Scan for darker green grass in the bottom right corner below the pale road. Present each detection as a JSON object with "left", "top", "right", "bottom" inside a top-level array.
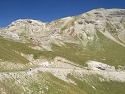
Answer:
[{"left": 67, "top": 74, "right": 125, "bottom": 94}]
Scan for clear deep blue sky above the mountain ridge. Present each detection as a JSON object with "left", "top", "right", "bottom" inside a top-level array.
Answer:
[{"left": 0, "top": 0, "right": 125, "bottom": 27}]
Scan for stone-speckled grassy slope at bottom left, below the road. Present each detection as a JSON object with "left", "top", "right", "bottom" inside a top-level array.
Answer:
[{"left": 0, "top": 72, "right": 88, "bottom": 94}]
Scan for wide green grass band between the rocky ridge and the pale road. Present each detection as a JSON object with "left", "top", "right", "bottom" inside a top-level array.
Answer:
[{"left": 0, "top": 27, "right": 125, "bottom": 66}]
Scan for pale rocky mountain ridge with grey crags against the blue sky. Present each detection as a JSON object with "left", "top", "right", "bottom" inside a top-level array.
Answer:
[{"left": 0, "top": 8, "right": 125, "bottom": 46}]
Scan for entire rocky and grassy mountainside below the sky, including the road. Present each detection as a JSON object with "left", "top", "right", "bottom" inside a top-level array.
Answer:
[{"left": 0, "top": 8, "right": 125, "bottom": 94}]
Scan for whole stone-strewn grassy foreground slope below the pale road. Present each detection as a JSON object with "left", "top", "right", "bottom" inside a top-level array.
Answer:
[{"left": 0, "top": 71, "right": 125, "bottom": 94}]
